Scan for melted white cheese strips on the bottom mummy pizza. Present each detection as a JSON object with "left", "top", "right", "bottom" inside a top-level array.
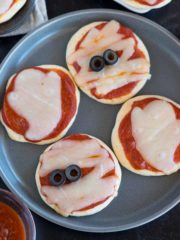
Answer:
[{"left": 39, "top": 139, "right": 117, "bottom": 215}]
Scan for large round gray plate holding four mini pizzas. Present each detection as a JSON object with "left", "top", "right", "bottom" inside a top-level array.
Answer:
[{"left": 0, "top": 9, "right": 180, "bottom": 232}]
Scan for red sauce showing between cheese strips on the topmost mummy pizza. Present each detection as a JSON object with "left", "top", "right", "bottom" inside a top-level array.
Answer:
[{"left": 72, "top": 22, "right": 145, "bottom": 99}]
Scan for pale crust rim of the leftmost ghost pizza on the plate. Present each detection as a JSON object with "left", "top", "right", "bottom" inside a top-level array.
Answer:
[{"left": 0, "top": 65, "right": 80, "bottom": 145}]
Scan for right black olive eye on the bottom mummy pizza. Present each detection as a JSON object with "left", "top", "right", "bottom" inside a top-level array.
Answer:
[{"left": 65, "top": 165, "right": 82, "bottom": 182}]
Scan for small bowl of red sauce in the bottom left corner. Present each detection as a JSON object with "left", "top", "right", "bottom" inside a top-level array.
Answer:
[{"left": 0, "top": 189, "right": 36, "bottom": 240}]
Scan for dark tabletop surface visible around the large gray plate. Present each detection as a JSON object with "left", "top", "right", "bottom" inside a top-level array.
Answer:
[{"left": 0, "top": 0, "right": 180, "bottom": 240}]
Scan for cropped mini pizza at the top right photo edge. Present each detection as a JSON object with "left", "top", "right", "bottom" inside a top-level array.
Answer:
[{"left": 115, "top": 0, "right": 172, "bottom": 13}]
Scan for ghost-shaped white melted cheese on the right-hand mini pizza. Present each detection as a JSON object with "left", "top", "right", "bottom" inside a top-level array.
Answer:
[{"left": 131, "top": 100, "right": 180, "bottom": 172}]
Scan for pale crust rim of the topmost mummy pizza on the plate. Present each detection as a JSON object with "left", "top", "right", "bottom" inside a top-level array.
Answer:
[{"left": 66, "top": 21, "right": 150, "bottom": 104}]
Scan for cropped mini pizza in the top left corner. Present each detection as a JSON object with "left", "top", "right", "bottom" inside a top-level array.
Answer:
[{"left": 0, "top": 0, "right": 27, "bottom": 24}]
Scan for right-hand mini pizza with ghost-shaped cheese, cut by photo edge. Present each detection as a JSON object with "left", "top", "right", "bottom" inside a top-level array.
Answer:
[{"left": 112, "top": 95, "right": 180, "bottom": 176}]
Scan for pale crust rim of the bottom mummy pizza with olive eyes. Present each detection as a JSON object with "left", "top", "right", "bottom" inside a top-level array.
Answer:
[{"left": 35, "top": 134, "right": 121, "bottom": 217}]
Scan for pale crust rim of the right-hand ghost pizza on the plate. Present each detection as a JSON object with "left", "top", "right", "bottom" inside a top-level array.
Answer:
[{"left": 111, "top": 95, "right": 180, "bottom": 176}]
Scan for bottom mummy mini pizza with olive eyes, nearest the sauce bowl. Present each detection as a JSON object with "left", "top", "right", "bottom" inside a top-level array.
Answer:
[{"left": 36, "top": 134, "right": 121, "bottom": 217}]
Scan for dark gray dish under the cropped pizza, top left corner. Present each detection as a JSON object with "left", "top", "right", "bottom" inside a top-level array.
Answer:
[{"left": 0, "top": 0, "right": 36, "bottom": 35}]
